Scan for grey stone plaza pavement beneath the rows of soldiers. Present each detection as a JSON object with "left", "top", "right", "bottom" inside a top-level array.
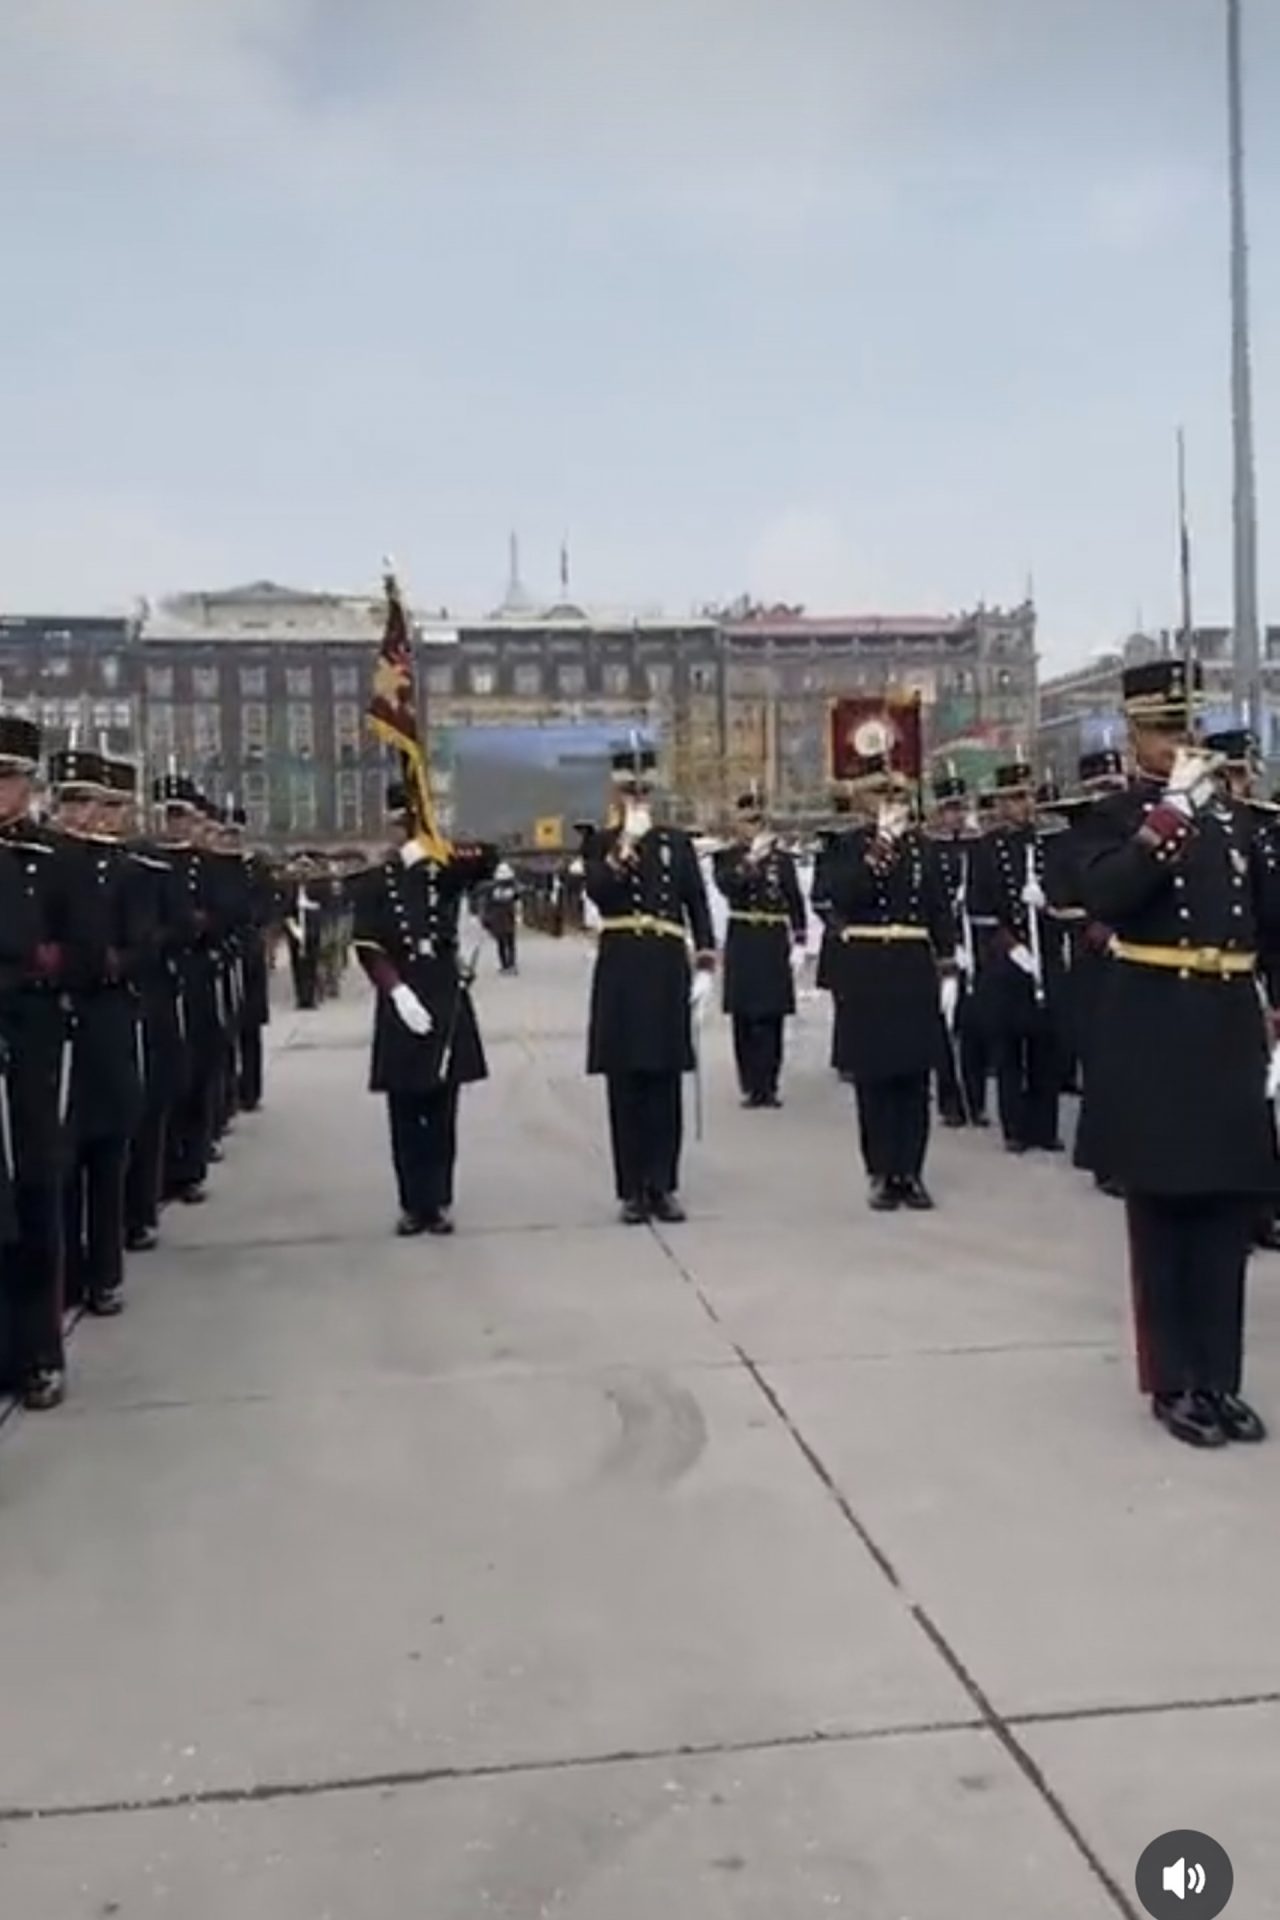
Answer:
[{"left": 0, "top": 939, "right": 1280, "bottom": 1920}]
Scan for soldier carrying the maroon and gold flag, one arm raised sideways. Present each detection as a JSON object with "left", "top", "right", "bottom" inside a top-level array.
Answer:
[{"left": 351, "top": 787, "right": 497, "bottom": 1236}]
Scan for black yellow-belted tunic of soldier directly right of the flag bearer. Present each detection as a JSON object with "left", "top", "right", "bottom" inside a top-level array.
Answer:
[{"left": 585, "top": 826, "right": 716, "bottom": 1073}]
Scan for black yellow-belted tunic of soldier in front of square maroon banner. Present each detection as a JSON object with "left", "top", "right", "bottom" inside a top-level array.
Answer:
[{"left": 825, "top": 826, "right": 956, "bottom": 1083}]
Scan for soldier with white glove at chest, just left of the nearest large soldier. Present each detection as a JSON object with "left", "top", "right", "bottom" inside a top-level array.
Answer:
[{"left": 971, "top": 760, "right": 1065, "bottom": 1154}]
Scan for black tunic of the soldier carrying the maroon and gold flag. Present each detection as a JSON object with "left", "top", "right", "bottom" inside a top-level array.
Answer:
[{"left": 351, "top": 845, "right": 497, "bottom": 1094}]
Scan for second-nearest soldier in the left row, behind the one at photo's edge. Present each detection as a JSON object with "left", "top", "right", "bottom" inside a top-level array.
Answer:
[{"left": 48, "top": 747, "right": 152, "bottom": 1317}]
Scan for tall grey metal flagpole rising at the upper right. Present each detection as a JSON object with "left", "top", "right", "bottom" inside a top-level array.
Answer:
[{"left": 1226, "top": 0, "right": 1268, "bottom": 753}]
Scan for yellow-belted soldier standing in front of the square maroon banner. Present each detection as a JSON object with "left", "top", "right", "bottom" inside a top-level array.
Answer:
[{"left": 827, "top": 756, "right": 956, "bottom": 1213}]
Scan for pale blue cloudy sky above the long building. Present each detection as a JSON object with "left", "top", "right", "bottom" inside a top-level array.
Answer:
[{"left": 0, "top": 0, "right": 1280, "bottom": 668}]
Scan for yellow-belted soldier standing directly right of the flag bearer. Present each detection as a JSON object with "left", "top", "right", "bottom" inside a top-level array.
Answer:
[{"left": 585, "top": 743, "right": 716, "bottom": 1225}]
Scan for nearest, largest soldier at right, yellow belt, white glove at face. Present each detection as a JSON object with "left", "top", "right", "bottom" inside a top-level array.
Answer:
[{"left": 1082, "top": 660, "right": 1280, "bottom": 1446}]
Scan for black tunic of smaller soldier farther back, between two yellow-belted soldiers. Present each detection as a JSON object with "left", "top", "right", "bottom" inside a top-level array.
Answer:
[{"left": 714, "top": 845, "right": 808, "bottom": 1020}]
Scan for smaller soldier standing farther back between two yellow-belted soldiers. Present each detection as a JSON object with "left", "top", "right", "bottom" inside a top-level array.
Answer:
[{"left": 712, "top": 787, "right": 808, "bottom": 1106}]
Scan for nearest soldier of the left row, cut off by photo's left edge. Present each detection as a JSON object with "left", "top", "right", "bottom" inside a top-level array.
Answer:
[{"left": 0, "top": 714, "right": 79, "bottom": 1409}]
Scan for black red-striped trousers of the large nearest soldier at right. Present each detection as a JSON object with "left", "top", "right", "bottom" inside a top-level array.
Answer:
[{"left": 1125, "top": 1194, "right": 1257, "bottom": 1394}]
